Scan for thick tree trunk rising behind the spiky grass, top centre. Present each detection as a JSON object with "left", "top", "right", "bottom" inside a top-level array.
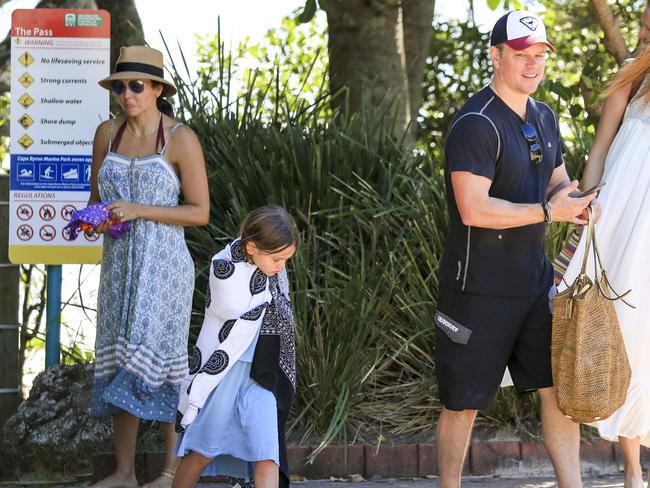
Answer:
[{"left": 327, "top": 0, "right": 434, "bottom": 142}]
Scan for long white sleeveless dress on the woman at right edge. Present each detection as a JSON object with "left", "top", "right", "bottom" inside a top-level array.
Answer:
[{"left": 559, "top": 74, "right": 650, "bottom": 447}]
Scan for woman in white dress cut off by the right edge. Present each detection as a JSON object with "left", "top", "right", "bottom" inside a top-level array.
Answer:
[{"left": 562, "top": 4, "right": 650, "bottom": 488}]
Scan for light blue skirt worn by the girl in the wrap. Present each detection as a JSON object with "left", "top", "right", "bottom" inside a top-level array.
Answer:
[{"left": 176, "top": 360, "right": 280, "bottom": 480}]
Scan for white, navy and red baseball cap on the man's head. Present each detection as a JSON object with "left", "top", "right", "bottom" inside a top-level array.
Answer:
[{"left": 490, "top": 10, "right": 555, "bottom": 52}]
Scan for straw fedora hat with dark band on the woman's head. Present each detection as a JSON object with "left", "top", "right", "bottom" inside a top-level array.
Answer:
[{"left": 99, "top": 46, "right": 176, "bottom": 97}]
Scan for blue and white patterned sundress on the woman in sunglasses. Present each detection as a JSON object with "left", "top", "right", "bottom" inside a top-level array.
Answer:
[{"left": 91, "top": 122, "right": 194, "bottom": 422}]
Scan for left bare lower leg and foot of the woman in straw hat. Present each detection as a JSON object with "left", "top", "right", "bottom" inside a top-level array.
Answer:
[{"left": 89, "top": 412, "right": 140, "bottom": 488}]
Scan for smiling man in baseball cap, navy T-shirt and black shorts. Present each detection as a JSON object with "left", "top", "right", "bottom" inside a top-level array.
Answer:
[{"left": 434, "top": 10, "right": 593, "bottom": 488}]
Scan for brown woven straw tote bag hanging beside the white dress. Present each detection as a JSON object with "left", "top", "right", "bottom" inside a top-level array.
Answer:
[{"left": 551, "top": 207, "right": 632, "bottom": 423}]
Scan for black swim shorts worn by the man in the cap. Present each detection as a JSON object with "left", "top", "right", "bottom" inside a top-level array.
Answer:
[{"left": 434, "top": 287, "right": 553, "bottom": 410}]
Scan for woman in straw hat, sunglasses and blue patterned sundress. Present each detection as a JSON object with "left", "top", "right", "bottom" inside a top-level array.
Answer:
[{"left": 89, "top": 46, "right": 210, "bottom": 488}]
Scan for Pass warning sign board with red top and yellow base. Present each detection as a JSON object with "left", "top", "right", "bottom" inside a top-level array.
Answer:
[{"left": 9, "top": 8, "right": 111, "bottom": 264}]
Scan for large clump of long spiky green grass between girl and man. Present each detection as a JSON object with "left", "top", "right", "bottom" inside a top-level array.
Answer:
[{"left": 165, "top": 33, "right": 446, "bottom": 442}]
